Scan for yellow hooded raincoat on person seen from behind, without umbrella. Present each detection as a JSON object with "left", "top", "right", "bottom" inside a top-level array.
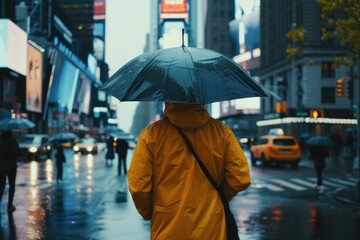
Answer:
[{"left": 128, "top": 103, "right": 250, "bottom": 240}]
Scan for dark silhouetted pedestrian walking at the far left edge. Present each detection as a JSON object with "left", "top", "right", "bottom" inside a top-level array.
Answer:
[{"left": 0, "top": 131, "right": 19, "bottom": 211}]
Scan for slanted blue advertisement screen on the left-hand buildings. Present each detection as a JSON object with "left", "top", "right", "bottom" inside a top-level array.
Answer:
[{"left": 48, "top": 52, "right": 80, "bottom": 114}]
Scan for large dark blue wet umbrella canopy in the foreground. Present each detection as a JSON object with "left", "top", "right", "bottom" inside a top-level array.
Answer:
[{"left": 101, "top": 46, "right": 267, "bottom": 104}]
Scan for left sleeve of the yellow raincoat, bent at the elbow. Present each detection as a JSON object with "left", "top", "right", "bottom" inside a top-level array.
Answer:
[{"left": 128, "top": 136, "right": 153, "bottom": 220}]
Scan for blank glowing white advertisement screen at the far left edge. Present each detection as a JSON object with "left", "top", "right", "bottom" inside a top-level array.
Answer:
[{"left": 0, "top": 19, "right": 27, "bottom": 76}]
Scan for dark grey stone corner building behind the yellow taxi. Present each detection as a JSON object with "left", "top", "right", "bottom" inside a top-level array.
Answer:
[{"left": 258, "top": 0, "right": 359, "bottom": 136}]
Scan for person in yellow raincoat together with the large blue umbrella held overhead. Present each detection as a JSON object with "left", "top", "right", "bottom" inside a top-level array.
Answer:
[{"left": 100, "top": 29, "right": 267, "bottom": 240}]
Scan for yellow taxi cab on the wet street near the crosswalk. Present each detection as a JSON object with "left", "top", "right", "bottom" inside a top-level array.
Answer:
[{"left": 250, "top": 135, "right": 301, "bottom": 168}]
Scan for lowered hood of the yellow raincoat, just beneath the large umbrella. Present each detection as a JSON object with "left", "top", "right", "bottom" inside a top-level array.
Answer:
[{"left": 164, "top": 102, "right": 210, "bottom": 129}]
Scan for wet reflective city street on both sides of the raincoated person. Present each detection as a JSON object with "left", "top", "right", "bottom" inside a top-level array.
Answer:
[{"left": 0, "top": 143, "right": 360, "bottom": 240}]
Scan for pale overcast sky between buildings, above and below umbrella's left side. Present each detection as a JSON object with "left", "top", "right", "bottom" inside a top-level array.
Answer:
[{"left": 105, "top": 0, "right": 150, "bottom": 131}]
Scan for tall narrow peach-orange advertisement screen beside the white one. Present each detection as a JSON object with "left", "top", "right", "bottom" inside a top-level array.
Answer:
[{"left": 26, "top": 44, "right": 43, "bottom": 113}]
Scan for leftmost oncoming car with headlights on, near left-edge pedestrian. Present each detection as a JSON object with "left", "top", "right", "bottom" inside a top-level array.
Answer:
[{"left": 19, "top": 134, "right": 53, "bottom": 159}]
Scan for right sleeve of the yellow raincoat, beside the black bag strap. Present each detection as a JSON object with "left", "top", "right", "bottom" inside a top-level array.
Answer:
[{"left": 222, "top": 132, "right": 251, "bottom": 201}]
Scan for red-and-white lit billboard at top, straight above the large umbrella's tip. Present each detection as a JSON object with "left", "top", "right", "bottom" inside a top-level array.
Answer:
[{"left": 160, "top": 0, "right": 188, "bottom": 20}]
